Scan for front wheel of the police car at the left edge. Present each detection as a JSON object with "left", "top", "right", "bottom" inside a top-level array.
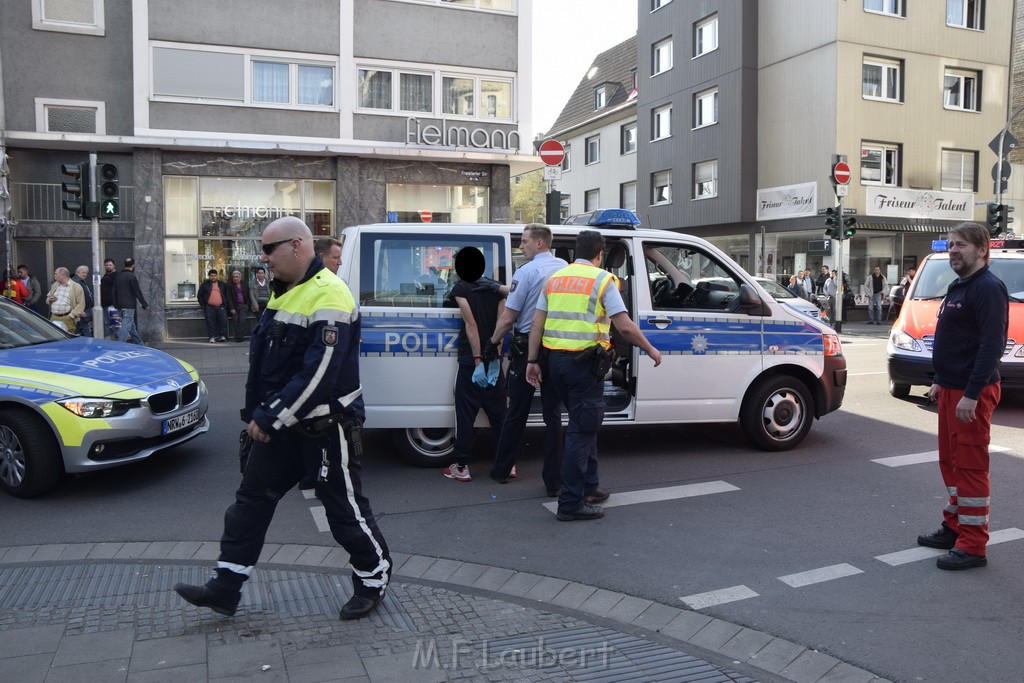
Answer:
[{"left": 0, "top": 410, "right": 60, "bottom": 498}]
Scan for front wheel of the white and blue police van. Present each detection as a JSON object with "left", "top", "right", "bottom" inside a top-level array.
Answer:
[{"left": 739, "top": 376, "right": 814, "bottom": 451}]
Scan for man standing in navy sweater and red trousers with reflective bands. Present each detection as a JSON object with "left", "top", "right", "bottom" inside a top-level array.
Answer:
[{"left": 918, "top": 223, "right": 1010, "bottom": 569}]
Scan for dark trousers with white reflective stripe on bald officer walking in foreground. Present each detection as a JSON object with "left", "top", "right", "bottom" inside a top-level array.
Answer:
[{"left": 218, "top": 426, "right": 391, "bottom": 597}]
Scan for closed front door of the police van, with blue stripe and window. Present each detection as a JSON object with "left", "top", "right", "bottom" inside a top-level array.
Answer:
[{"left": 636, "top": 239, "right": 763, "bottom": 423}]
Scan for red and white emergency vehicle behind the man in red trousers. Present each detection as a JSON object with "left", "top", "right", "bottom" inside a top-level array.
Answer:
[{"left": 886, "top": 240, "right": 1024, "bottom": 398}]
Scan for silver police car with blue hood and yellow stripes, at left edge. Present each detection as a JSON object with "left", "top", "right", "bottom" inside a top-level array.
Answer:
[{"left": 0, "top": 298, "right": 210, "bottom": 498}]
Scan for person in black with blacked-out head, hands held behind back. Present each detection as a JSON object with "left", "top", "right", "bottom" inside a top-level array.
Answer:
[{"left": 443, "top": 247, "right": 505, "bottom": 481}]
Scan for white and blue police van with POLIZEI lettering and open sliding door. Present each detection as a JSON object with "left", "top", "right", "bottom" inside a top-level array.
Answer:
[{"left": 338, "top": 210, "right": 846, "bottom": 466}]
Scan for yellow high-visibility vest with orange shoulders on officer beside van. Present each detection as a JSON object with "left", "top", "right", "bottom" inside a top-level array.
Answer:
[{"left": 541, "top": 263, "right": 618, "bottom": 351}]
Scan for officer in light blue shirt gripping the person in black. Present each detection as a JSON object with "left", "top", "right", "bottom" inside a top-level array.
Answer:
[{"left": 483, "top": 223, "right": 568, "bottom": 497}]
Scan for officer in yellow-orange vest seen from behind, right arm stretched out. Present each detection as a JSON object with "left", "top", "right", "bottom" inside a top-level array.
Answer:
[{"left": 526, "top": 230, "right": 662, "bottom": 521}]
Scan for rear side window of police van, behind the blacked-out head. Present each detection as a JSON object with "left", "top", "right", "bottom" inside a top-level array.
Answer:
[{"left": 359, "top": 232, "right": 505, "bottom": 308}]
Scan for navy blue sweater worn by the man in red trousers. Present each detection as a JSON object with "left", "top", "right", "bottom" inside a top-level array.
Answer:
[{"left": 932, "top": 265, "right": 1010, "bottom": 399}]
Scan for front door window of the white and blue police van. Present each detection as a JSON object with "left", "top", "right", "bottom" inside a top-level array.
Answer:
[{"left": 643, "top": 243, "right": 740, "bottom": 310}]
